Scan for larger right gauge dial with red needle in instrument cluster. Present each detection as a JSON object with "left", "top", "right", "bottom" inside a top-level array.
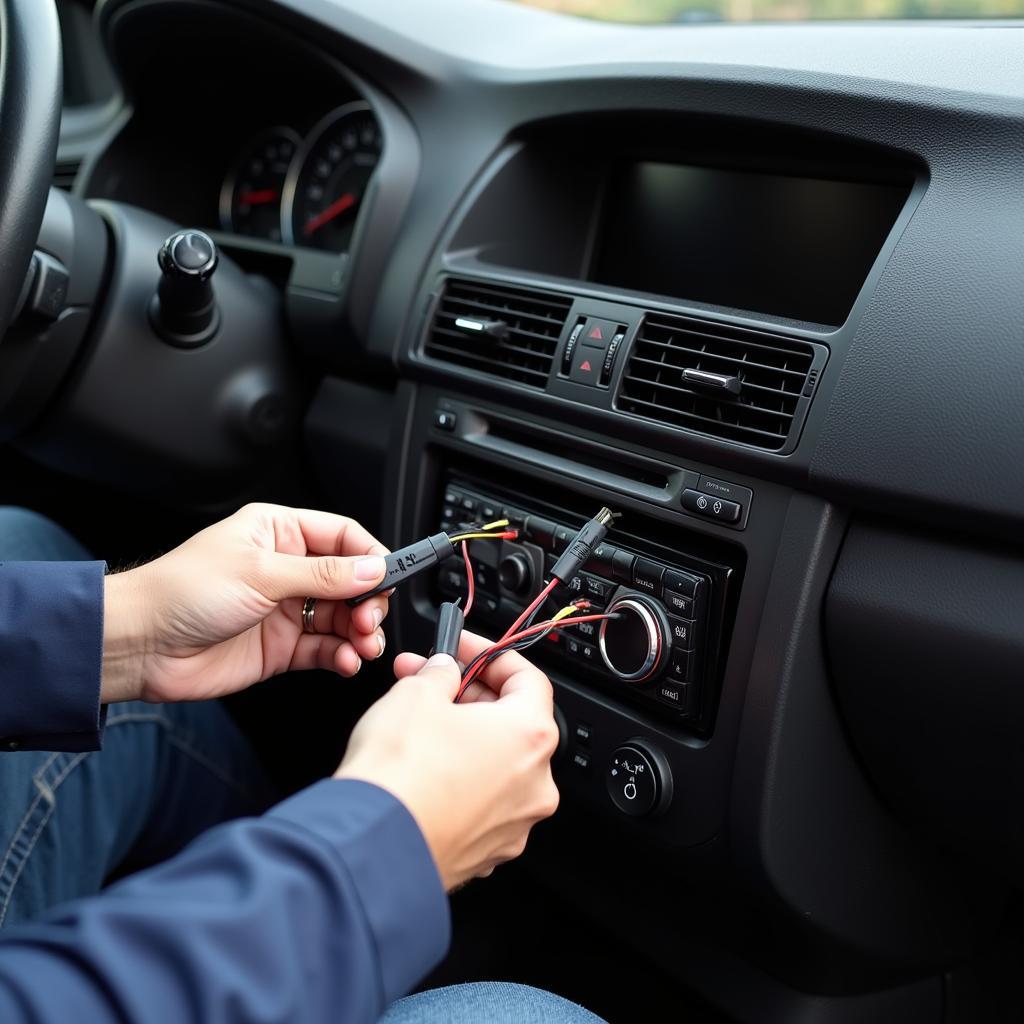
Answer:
[{"left": 281, "top": 102, "right": 381, "bottom": 252}]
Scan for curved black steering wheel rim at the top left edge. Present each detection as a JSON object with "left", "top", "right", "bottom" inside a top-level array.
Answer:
[{"left": 0, "top": 0, "right": 62, "bottom": 338}]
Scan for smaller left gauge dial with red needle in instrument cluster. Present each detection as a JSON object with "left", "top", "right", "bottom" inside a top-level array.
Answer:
[{"left": 220, "top": 128, "right": 302, "bottom": 242}]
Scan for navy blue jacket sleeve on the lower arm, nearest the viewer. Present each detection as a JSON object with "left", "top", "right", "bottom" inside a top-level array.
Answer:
[{"left": 0, "top": 780, "right": 450, "bottom": 1024}]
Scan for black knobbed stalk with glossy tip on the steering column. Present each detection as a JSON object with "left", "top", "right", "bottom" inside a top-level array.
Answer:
[{"left": 150, "top": 229, "right": 220, "bottom": 348}]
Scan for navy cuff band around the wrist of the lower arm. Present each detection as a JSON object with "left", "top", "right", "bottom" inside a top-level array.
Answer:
[{"left": 268, "top": 779, "right": 452, "bottom": 1006}]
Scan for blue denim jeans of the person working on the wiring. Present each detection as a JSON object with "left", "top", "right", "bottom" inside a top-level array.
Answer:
[{"left": 0, "top": 508, "right": 602, "bottom": 1024}]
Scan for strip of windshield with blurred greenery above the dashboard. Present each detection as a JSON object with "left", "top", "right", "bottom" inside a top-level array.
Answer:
[{"left": 510, "top": 0, "right": 1024, "bottom": 25}]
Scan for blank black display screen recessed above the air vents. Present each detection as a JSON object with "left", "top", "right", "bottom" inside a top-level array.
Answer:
[{"left": 591, "top": 163, "right": 909, "bottom": 325}]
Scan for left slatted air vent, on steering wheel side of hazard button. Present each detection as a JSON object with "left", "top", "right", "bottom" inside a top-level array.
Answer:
[{"left": 424, "top": 279, "right": 572, "bottom": 388}]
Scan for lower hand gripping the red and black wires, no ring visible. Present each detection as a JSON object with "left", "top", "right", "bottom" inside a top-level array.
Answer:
[{"left": 335, "top": 633, "right": 558, "bottom": 890}]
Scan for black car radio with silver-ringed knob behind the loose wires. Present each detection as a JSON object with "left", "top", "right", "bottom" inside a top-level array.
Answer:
[{"left": 438, "top": 478, "right": 731, "bottom": 726}]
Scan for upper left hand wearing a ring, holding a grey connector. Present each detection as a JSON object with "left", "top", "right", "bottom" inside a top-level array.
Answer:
[{"left": 101, "top": 505, "right": 388, "bottom": 702}]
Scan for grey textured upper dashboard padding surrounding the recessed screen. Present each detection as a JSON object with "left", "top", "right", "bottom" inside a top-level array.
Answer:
[{"left": 239, "top": 0, "right": 1024, "bottom": 530}]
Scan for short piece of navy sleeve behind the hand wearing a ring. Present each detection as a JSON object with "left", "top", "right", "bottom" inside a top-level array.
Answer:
[{"left": 0, "top": 562, "right": 106, "bottom": 751}]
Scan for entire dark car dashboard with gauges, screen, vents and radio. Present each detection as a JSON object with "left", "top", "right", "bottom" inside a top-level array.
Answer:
[{"left": 54, "top": 0, "right": 1024, "bottom": 1022}]
